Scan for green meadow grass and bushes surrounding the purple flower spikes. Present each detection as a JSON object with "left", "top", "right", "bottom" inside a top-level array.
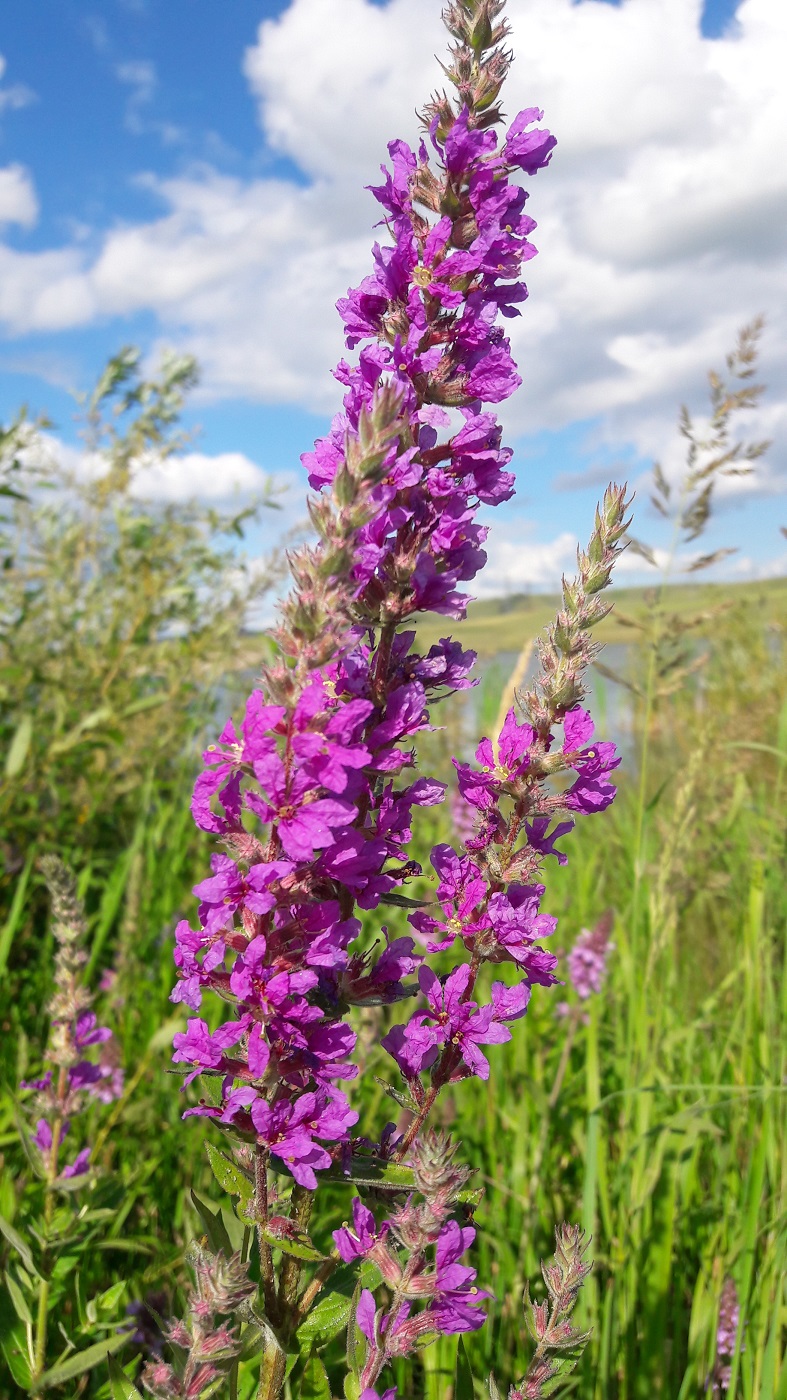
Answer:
[{"left": 0, "top": 344, "right": 787, "bottom": 1400}]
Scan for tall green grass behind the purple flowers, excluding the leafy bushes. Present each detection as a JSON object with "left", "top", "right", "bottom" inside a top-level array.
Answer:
[{"left": 0, "top": 581, "right": 787, "bottom": 1400}]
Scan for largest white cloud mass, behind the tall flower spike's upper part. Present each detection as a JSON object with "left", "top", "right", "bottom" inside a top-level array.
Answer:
[{"left": 0, "top": 0, "right": 787, "bottom": 501}]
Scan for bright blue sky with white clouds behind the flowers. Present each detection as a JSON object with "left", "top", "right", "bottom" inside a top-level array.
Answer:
[{"left": 0, "top": 0, "right": 787, "bottom": 591}]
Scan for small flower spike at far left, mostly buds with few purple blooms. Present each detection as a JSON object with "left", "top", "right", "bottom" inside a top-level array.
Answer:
[{"left": 21, "top": 855, "right": 123, "bottom": 1182}]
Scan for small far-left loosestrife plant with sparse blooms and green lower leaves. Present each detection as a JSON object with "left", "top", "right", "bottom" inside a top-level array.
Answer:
[{"left": 0, "top": 855, "right": 130, "bottom": 1394}]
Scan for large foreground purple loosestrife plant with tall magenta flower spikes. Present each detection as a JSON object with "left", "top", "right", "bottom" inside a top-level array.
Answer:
[{"left": 161, "top": 0, "right": 626, "bottom": 1400}]
